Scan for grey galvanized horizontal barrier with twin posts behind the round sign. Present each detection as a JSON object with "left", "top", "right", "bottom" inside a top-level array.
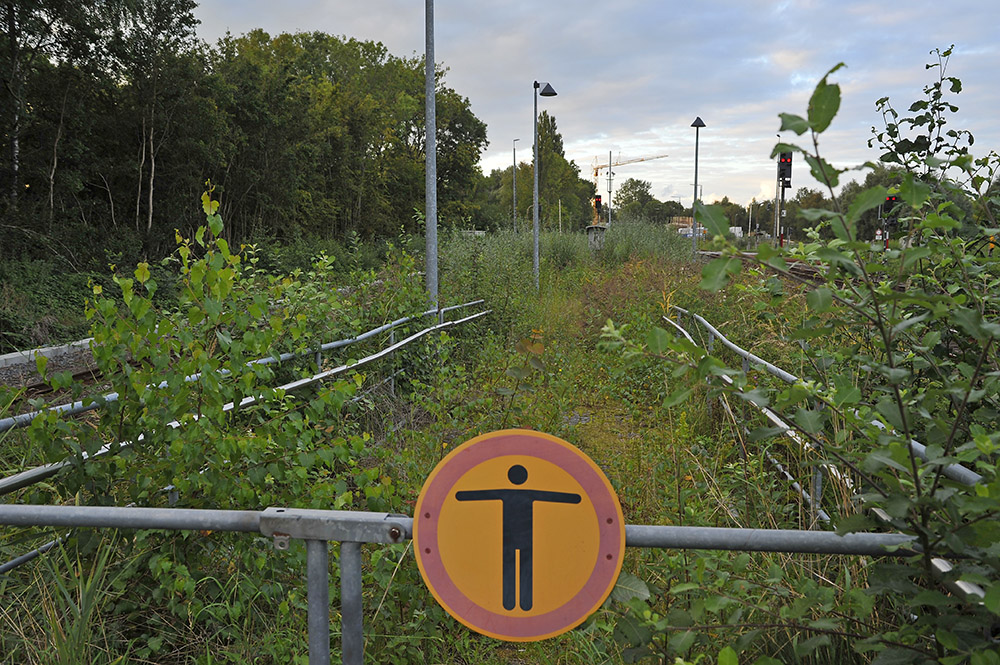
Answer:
[{"left": 0, "top": 504, "right": 914, "bottom": 665}]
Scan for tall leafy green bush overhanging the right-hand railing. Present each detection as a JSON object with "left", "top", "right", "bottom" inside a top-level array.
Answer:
[{"left": 605, "top": 48, "right": 1000, "bottom": 665}]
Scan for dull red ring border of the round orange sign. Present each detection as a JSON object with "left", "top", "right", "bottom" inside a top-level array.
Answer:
[{"left": 413, "top": 429, "right": 625, "bottom": 642}]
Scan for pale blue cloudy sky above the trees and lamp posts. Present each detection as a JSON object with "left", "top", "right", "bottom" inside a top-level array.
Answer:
[{"left": 195, "top": 0, "right": 1000, "bottom": 205}]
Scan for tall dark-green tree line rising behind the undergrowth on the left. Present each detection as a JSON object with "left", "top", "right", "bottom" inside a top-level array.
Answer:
[{"left": 0, "top": 0, "right": 589, "bottom": 269}]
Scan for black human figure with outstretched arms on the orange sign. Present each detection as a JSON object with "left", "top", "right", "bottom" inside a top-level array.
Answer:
[{"left": 455, "top": 464, "right": 580, "bottom": 611}]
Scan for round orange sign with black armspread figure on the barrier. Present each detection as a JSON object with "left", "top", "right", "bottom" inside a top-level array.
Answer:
[{"left": 413, "top": 429, "right": 625, "bottom": 642}]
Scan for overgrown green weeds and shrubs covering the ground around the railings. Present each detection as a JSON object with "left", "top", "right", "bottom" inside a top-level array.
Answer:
[{"left": 0, "top": 45, "right": 1000, "bottom": 665}]
